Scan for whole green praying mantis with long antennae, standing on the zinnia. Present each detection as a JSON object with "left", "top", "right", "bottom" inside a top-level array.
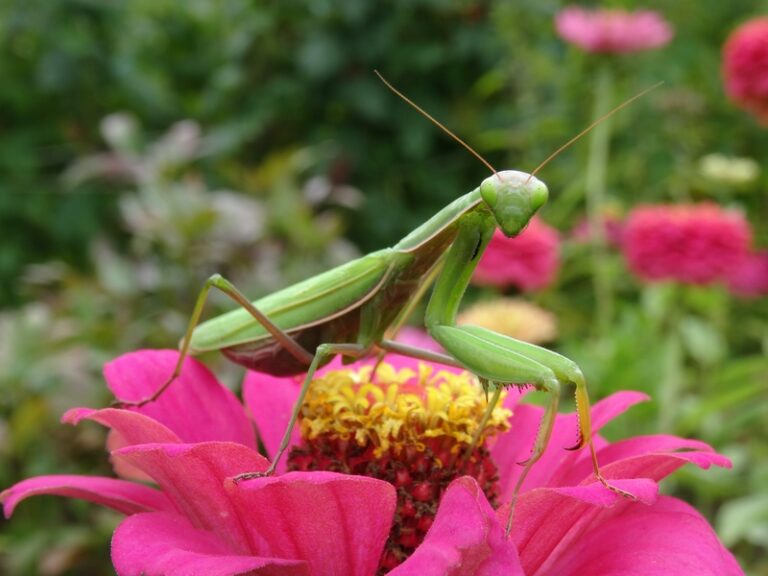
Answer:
[{"left": 123, "top": 73, "right": 656, "bottom": 530}]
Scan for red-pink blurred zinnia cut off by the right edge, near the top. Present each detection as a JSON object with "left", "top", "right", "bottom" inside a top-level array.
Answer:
[{"left": 723, "top": 18, "right": 768, "bottom": 123}]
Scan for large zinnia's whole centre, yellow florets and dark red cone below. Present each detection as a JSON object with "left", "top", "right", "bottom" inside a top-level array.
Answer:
[{"left": 288, "top": 363, "right": 511, "bottom": 571}]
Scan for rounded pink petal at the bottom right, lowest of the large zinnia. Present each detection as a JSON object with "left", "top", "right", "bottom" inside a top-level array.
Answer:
[{"left": 538, "top": 496, "right": 743, "bottom": 576}]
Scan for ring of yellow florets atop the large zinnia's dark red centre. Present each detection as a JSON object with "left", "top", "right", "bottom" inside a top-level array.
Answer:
[{"left": 301, "top": 363, "right": 511, "bottom": 456}]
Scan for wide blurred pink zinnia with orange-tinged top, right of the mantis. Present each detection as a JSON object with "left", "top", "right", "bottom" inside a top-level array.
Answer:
[{"left": 622, "top": 203, "right": 752, "bottom": 284}]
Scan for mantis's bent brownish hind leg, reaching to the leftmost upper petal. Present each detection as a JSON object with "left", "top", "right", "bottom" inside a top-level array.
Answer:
[{"left": 113, "top": 274, "right": 313, "bottom": 408}]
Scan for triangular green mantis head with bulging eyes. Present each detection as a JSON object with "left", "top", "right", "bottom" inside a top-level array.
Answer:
[{"left": 480, "top": 170, "right": 549, "bottom": 237}]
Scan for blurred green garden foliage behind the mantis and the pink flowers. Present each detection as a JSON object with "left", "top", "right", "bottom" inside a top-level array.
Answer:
[{"left": 0, "top": 0, "right": 768, "bottom": 576}]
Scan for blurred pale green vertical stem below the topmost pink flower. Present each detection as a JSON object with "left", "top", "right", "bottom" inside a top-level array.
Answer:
[{"left": 586, "top": 66, "right": 613, "bottom": 338}]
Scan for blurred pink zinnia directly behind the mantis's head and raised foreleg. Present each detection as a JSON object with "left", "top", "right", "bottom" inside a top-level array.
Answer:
[{"left": 472, "top": 218, "right": 560, "bottom": 291}]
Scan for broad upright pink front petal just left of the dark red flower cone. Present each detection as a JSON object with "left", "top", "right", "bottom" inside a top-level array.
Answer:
[{"left": 228, "top": 472, "right": 396, "bottom": 576}]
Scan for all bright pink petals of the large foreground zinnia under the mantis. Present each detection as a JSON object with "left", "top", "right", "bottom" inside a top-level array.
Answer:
[{"left": 2, "top": 351, "right": 742, "bottom": 576}]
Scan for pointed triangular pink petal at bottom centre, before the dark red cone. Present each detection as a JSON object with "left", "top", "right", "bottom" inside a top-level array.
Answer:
[{"left": 389, "top": 476, "right": 523, "bottom": 576}]
